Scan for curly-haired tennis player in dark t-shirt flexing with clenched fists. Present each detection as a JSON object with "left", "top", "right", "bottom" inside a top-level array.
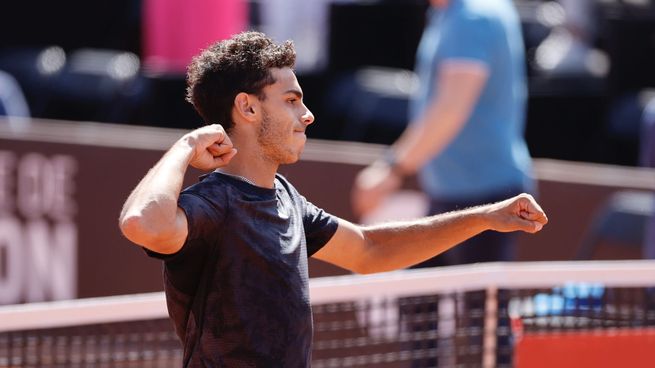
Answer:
[{"left": 119, "top": 32, "right": 548, "bottom": 368}]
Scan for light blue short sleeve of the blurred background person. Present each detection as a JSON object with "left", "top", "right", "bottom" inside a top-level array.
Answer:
[{"left": 439, "top": 13, "right": 498, "bottom": 64}]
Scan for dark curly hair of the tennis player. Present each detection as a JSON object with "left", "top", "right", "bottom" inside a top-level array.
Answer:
[{"left": 186, "top": 32, "right": 296, "bottom": 131}]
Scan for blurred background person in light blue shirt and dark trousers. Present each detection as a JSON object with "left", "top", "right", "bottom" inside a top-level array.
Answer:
[{"left": 352, "top": 0, "right": 534, "bottom": 267}]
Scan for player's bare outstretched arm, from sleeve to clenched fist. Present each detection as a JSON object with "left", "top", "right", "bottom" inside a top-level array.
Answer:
[{"left": 314, "top": 194, "right": 548, "bottom": 273}]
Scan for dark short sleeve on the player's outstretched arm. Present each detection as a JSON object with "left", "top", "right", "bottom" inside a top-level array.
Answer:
[{"left": 303, "top": 198, "right": 339, "bottom": 257}]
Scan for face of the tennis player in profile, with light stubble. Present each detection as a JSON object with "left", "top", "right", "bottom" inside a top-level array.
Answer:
[{"left": 257, "top": 68, "right": 314, "bottom": 164}]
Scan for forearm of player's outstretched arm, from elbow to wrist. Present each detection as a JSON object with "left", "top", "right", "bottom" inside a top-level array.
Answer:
[{"left": 362, "top": 207, "right": 490, "bottom": 273}]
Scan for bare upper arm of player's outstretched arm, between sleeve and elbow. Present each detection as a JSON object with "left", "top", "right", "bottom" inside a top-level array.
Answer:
[{"left": 313, "top": 219, "right": 368, "bottom": 272}]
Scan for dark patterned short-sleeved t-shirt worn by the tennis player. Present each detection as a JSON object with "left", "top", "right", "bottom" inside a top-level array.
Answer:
[{"left": 148, "top": 172, "right": 338, "bottom": 368}]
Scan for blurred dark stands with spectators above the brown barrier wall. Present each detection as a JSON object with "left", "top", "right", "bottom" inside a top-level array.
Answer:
[{"left": 0, "top": 0, "right": 655, "bottom": 170}]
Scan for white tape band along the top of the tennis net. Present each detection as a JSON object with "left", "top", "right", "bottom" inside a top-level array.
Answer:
[{"left": 0, "top": 260, "right": 655, "bottom": 332}]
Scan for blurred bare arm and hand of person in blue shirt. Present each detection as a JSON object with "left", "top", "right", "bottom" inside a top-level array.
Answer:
[{"left": 351, "top": 59, "right": 489, "bottom": 215}]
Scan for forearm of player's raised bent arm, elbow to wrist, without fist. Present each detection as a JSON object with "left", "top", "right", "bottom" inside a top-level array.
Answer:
[{"left": 119, "top": 140, "right": 193, "bottom": 243}]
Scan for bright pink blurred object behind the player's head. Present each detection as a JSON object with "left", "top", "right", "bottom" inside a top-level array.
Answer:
[{"left": 143, "top": 0, "right": 248, "bottom": 73}]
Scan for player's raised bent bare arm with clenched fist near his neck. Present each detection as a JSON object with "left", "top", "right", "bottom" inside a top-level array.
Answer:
[{"left": 119, "top": 124, "right": 236, "bottom": 254}]
